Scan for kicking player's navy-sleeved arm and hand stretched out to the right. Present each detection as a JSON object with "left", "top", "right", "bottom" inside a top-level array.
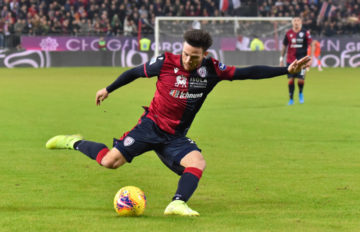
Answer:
[{"left": 233, "top": 56, "right": 310, "bottom": 80}]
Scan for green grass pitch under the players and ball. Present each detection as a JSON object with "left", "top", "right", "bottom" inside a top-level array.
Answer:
[{"left": 0, "top": 68, "right": 360, "bottom": 232}]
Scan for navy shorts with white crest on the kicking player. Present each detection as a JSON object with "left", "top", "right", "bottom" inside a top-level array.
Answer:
[{"left": 114, "top": 112, "right": 201, "bottom": 175}]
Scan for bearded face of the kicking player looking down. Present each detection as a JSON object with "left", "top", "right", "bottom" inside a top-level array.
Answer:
[{"left": 181, "top": 42, "right": 207, "bottom": 71}]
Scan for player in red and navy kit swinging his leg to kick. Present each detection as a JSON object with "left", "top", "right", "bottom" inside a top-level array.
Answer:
[{"left": 46, "top": 29, "right": 310, "bottom": 216}]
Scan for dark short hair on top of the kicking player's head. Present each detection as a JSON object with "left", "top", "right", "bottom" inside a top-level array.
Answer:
[{"left": 184, "top": 29, "right": 212, "bottom": 51}]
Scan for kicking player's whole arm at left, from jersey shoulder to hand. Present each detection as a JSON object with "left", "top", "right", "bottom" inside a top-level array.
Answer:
[{"left": 95, "top": 55, "right": 165, "bottom": 105}]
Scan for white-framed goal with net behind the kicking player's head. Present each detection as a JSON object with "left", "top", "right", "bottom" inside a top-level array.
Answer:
[{"left": 154, "top": 17, "right": 292, "bottom": 65}]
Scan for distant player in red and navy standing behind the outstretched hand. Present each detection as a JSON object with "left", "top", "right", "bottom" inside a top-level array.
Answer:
[{"left": 280, "top": 17, "right": 314, "bottom": 105}]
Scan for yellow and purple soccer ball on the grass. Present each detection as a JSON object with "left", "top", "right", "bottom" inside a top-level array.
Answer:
[{"left": 114, "top": 186, "right": 146, "bottom": 216}]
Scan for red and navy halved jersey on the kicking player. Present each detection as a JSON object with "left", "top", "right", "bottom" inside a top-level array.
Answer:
[{"left": 143, "top": 53, "right": 236, "bottom": 134}]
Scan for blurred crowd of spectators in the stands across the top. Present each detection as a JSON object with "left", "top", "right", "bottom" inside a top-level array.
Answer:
[{"left": 0, "top": 0, "right": 360, "bottom": 47}]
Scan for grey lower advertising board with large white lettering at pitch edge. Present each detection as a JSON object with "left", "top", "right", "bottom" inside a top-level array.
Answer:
[{"left": 0, "top": 50, "right": 360, "bottom": 68}]
